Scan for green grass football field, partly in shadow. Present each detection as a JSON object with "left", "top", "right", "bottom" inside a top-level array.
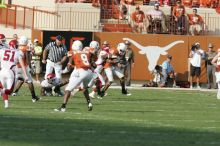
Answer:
[{"left": 0, "top": 86, "right": 220, "bottom": 146}]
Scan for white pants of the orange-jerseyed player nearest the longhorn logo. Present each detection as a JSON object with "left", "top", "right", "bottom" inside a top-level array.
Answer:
[{"left": 105, "top": 66, "right": 124, "bottom": 82}]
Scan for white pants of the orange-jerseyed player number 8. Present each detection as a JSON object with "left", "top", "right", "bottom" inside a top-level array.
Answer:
[{"left": 65, "top": 68, "right": 92, "bottom": 91}]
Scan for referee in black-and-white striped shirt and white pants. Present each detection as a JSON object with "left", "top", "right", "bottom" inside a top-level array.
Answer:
[{"left": 42, "top": 35, "right": 67, "bottom": 82}]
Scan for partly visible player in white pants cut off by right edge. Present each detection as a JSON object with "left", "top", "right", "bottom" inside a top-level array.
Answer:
[{"left": 212, "top": 49, "right": 220, "bottom": 99}]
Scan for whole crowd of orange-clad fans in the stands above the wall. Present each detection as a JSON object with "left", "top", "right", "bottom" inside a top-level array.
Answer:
[{"left": 55, "top": 0, "right": 218, "bottom": 35}]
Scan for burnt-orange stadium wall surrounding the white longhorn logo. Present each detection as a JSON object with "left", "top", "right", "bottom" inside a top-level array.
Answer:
[{"left": 94, "top": 32, "right": 220, "bottom": 82}]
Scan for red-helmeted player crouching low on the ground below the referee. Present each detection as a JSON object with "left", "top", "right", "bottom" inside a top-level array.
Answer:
[{"left": 41, "top": 73, "right": 69, "bottom": 96}]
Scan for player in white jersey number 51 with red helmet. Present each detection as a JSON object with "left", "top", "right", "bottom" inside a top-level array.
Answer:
[{"left": 0, "top": 40, "right": 28, "bottom": 108}]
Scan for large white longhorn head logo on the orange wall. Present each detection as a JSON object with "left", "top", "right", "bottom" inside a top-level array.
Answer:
[{"left": 123, "top": 38, "right": 184, "bottom": 71}]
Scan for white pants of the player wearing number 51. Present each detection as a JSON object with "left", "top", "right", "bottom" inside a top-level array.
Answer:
[{"left": 0, "top": 68, "right": 15, "bottom": 91}]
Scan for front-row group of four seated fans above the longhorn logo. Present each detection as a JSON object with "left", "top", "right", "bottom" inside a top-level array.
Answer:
[{"left": 131, "top": 1, "right": 205, "bottom": 35}]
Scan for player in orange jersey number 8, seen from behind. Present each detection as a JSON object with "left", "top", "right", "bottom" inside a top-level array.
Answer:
[{"left": 54, "top": 41, "right": 93, "bottom": 112}]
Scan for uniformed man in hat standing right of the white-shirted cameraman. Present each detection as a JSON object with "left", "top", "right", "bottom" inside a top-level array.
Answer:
[{"left": 205, "top": 43, "right": 217, "bottom": 89}]
